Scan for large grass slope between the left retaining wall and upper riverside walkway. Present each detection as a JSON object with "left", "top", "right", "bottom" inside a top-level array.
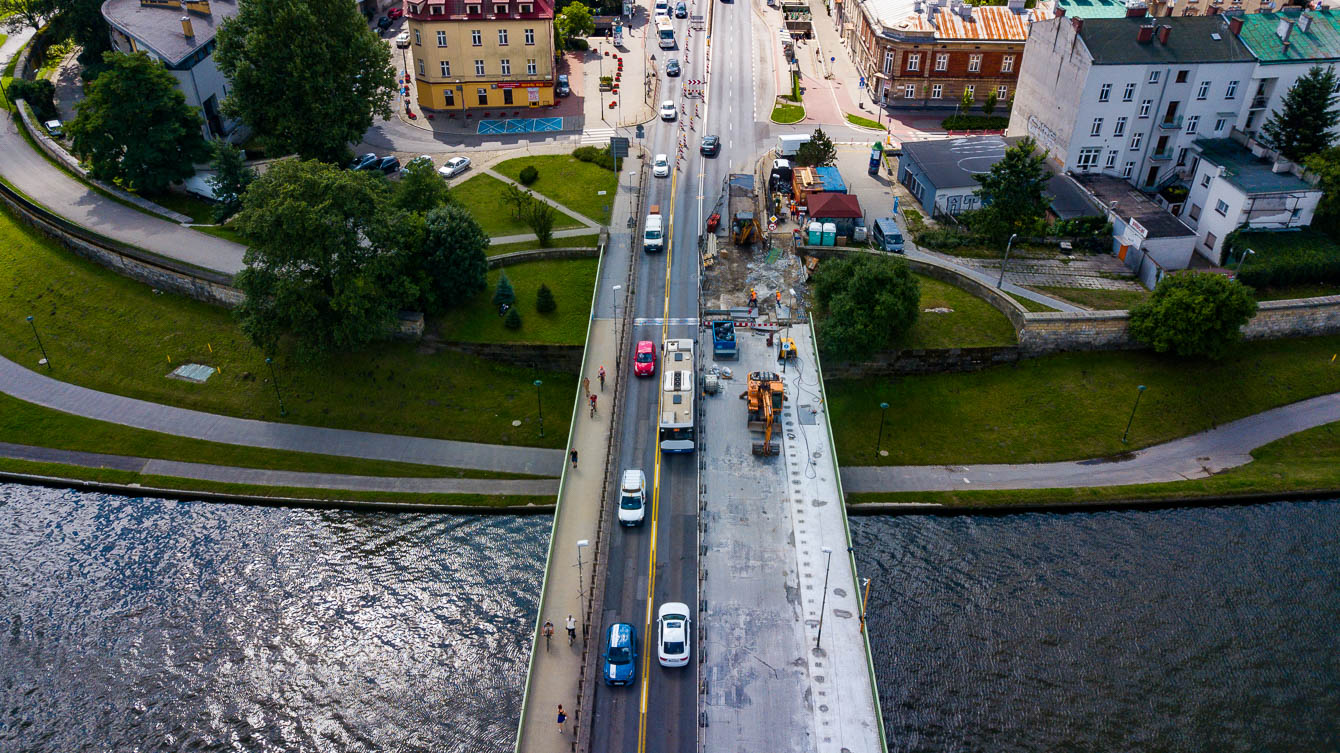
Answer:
[{"left": 0, "top": 202, "right": 576, "bottom": 448}]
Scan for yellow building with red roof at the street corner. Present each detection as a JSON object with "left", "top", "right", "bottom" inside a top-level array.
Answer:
[{"left": 405, "top": 0, "right": 553, "bottom": 110}]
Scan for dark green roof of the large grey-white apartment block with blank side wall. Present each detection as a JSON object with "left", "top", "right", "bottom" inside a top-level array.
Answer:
[{"left": 1080, "top": 16, "right": 1256, "bottom": 66}]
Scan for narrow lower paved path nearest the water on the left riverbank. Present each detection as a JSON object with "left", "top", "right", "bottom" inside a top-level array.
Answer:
[{"left": 0, "top": 442, "right": 559, "bottom": 497}]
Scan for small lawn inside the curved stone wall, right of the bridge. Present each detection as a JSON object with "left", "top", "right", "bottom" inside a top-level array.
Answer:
[{"left": 906, "top": 275, "right": 1017, "bottom": 348}]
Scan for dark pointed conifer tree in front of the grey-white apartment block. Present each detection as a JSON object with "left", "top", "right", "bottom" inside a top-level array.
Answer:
[{"left": 973, "top": 137, "right": 1052, "bottom": 244}]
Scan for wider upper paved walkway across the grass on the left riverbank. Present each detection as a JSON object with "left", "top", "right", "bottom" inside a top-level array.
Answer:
[{"left": 0, "top": 358, "right": 563, "bottom": 476}]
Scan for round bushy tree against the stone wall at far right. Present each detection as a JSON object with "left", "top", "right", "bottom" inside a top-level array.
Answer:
[{"left": 1131, "top": 272, "right": 1257, "bottom": 359}]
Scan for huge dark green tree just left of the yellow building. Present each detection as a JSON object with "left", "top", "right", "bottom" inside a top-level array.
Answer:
[{"left": 213, "top": 0, "right": 395, "bottom": 165}]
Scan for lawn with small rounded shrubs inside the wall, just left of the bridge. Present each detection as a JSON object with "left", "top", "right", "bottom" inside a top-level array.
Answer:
[{"left": 440, "top": 259, "right": 599, "bottom": 341}]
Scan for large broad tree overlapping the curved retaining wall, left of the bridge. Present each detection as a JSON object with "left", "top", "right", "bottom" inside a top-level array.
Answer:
[{"left": 235, "top": 159, "right": 407, "bottom": 359}]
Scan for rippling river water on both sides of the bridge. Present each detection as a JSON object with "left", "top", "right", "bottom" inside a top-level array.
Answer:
[{"left": 0, "top": 485, "right": 1340, "bottom": 753}]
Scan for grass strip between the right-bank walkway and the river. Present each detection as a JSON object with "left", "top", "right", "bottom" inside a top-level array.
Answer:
[{"left": 847, "top": 423, "right": 1340, "bottom": 506}]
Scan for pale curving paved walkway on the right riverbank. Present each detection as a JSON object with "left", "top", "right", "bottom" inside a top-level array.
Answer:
[{"left": 842, "top": 393, "right": 1340, "bottom": 492}]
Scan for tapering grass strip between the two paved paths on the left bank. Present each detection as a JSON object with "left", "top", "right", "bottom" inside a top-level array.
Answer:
[{"left": 0, "top": 394, "right": 525, "bottom": 478}]
